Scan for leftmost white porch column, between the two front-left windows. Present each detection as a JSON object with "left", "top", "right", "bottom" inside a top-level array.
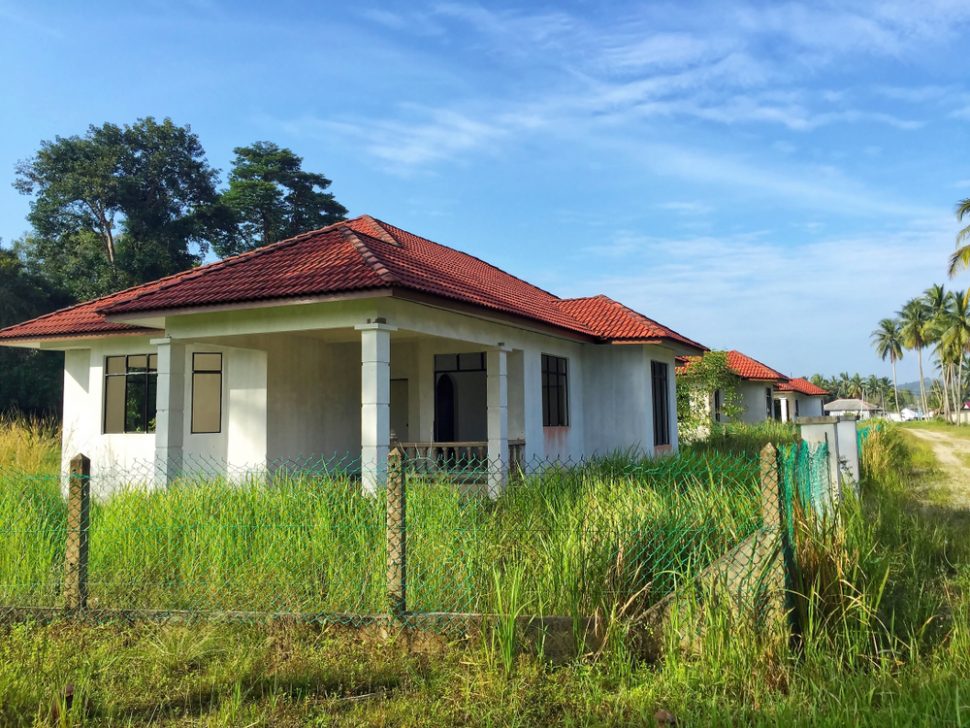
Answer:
[{"left": 149, "top": 337, "right": 185, "bottom": 487}]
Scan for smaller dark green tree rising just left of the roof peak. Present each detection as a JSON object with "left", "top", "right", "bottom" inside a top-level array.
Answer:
[{"left": 215, "top": 142, "right": 347, "bottom": 256}]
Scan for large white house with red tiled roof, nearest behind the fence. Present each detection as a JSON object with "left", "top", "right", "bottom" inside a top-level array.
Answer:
[{"left": 0, "top": 216, "right": 704, "bottom": 488}]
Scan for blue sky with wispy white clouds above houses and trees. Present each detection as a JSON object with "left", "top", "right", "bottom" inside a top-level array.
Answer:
[{"left": 0, "top": 0, "right": 970, "bottom": 380}]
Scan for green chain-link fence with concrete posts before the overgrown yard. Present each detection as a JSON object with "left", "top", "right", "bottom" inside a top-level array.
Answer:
[{"left": 0, "top": 446, "right": 828, "bottom": 636}]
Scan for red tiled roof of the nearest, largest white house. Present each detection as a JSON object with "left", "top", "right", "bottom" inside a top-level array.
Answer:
[{"left": 0, "top": 215, "right": 705, "bottom": 351}]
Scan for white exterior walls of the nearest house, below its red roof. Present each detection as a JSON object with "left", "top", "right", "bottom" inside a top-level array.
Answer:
[{"left": 54, "top": 299, "right": 688, "bottom": 484}]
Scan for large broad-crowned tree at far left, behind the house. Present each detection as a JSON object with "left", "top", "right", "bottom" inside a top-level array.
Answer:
[{"left": 14, "top": 117, "right": 231, "bottom": 297}]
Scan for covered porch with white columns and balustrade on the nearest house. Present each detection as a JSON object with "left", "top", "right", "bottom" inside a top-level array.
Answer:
[{"left": 152, "top": 318, "right": 542, "bottom": 496}]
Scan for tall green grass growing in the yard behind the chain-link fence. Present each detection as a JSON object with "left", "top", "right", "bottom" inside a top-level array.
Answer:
[{"left": 0, "top": 453, "right": 761, "bottom": 616}]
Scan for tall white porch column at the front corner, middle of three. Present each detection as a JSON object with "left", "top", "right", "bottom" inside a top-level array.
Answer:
[{"left": 355, "top": 323, "right": 395, "bottom": 493}]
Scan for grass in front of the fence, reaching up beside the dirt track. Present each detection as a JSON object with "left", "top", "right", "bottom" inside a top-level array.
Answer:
[{"left": 0, "top": 418, "right": 970, "bottom": 726}]
